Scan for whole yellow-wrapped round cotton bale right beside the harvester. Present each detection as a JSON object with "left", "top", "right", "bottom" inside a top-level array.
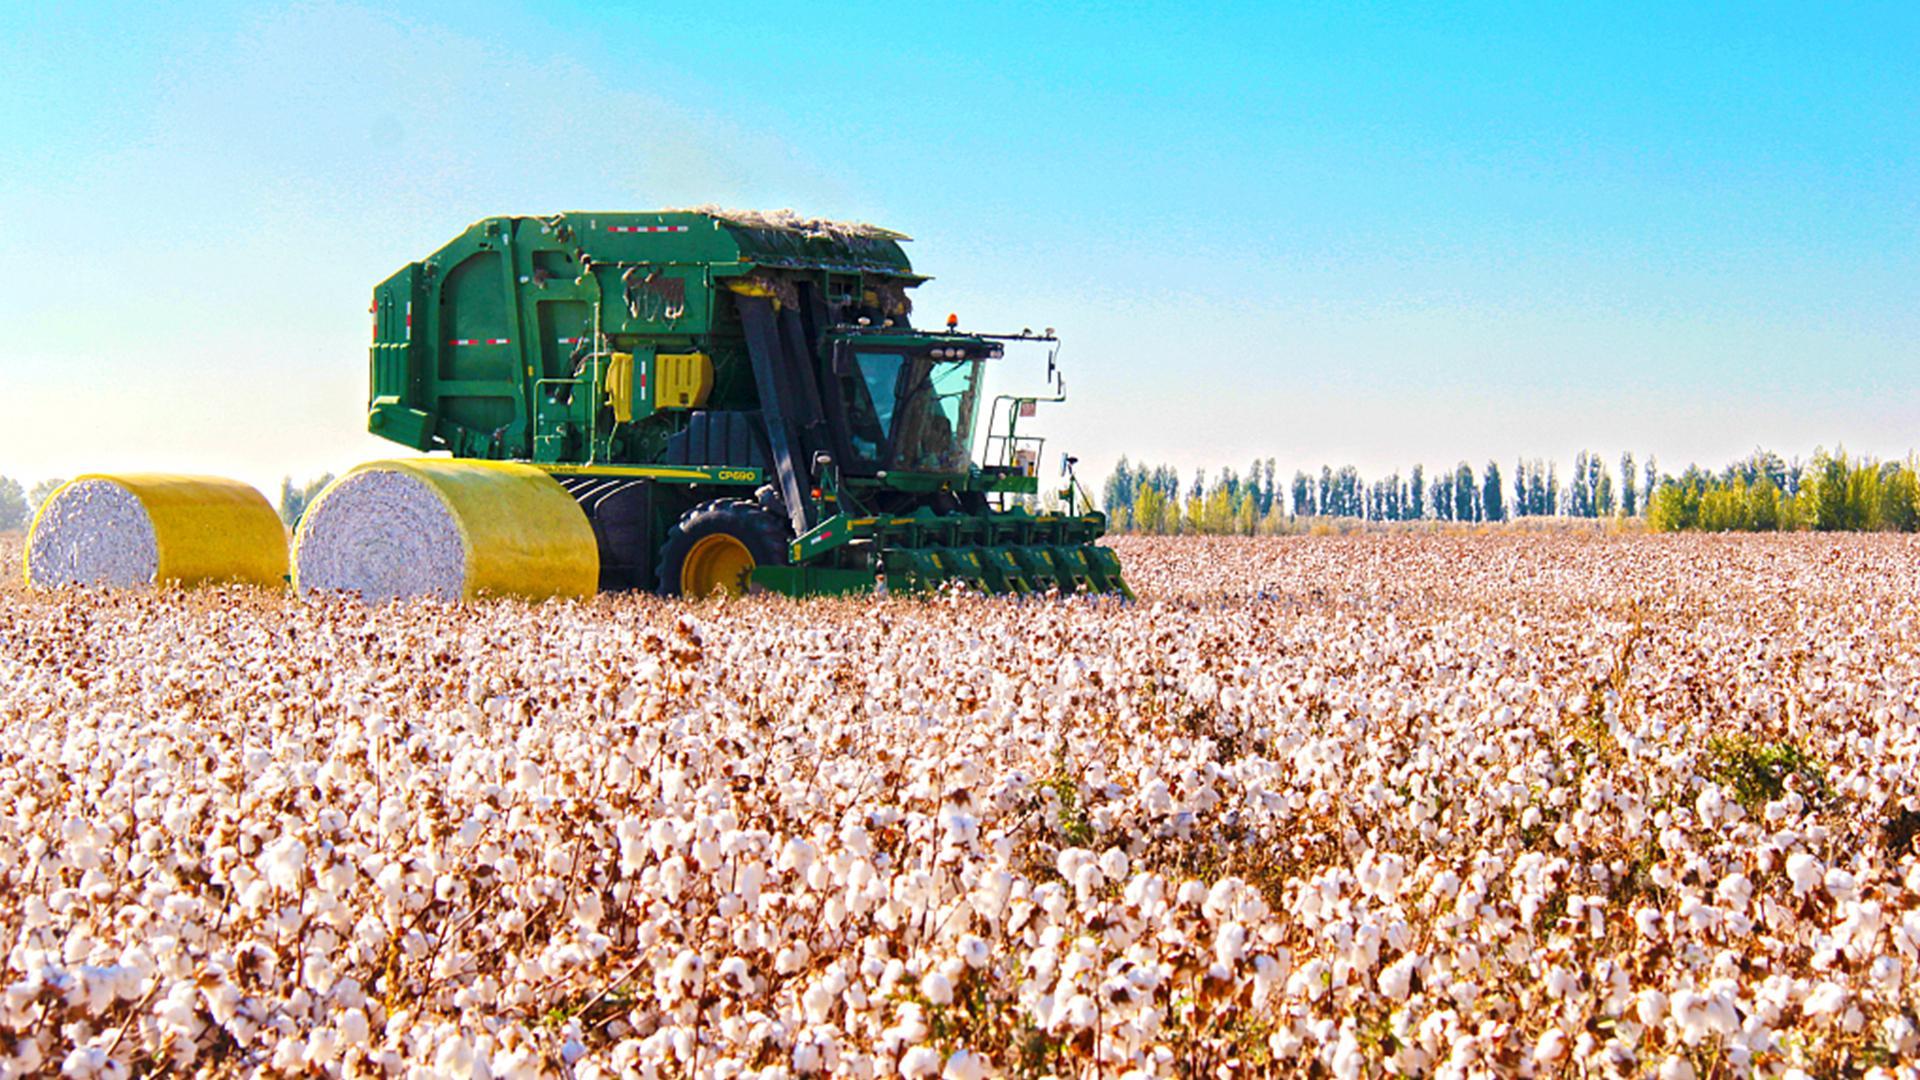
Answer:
[{"left": 294, "top": 457, "right": 599, "bottom": 603}]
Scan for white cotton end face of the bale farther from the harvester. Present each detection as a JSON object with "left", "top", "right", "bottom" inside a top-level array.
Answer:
[{"left": 27, "top": 480, "right": 159, "bottom": 588}]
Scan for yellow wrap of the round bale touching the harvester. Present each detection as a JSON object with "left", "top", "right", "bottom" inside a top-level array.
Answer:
[{"left": 294, "top": 457, "right": 599, "bottom": 600}]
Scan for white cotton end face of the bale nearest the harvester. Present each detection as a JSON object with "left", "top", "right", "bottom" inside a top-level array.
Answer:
[{"left": 294, "top": 469, "right": 467, "bottom": 603}]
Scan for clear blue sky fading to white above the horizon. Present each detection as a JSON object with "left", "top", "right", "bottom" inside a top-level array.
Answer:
[{"left": 0, "top": 0, "right": 1920, "bottom": 486}]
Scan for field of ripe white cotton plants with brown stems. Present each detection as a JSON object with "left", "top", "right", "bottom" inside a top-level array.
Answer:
[{"left": 0, "top": 534, "right": 1920, "bottom": 1078}]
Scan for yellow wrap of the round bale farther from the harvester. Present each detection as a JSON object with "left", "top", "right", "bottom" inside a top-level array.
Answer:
[{"left": 25, "top": 473, "right": 286, "bottom": 588}]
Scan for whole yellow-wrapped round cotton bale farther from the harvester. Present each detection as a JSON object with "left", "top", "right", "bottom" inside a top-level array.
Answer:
[{"left": 25, "top": 473, "right": 286, "bottom": 588}]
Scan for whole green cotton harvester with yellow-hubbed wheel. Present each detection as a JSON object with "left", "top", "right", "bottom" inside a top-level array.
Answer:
[{"left": 369, "top": 211, "right": 1125, "bottom": 596}]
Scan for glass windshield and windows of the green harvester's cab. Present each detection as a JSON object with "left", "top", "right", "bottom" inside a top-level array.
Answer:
[{"left": 841, "top": 352, "right": 981, "bottom": 473}]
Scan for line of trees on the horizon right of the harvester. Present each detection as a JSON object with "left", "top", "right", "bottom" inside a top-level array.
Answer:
[{"left": 1102, "top": 450, "right": 1920, "bottom": 536}]
